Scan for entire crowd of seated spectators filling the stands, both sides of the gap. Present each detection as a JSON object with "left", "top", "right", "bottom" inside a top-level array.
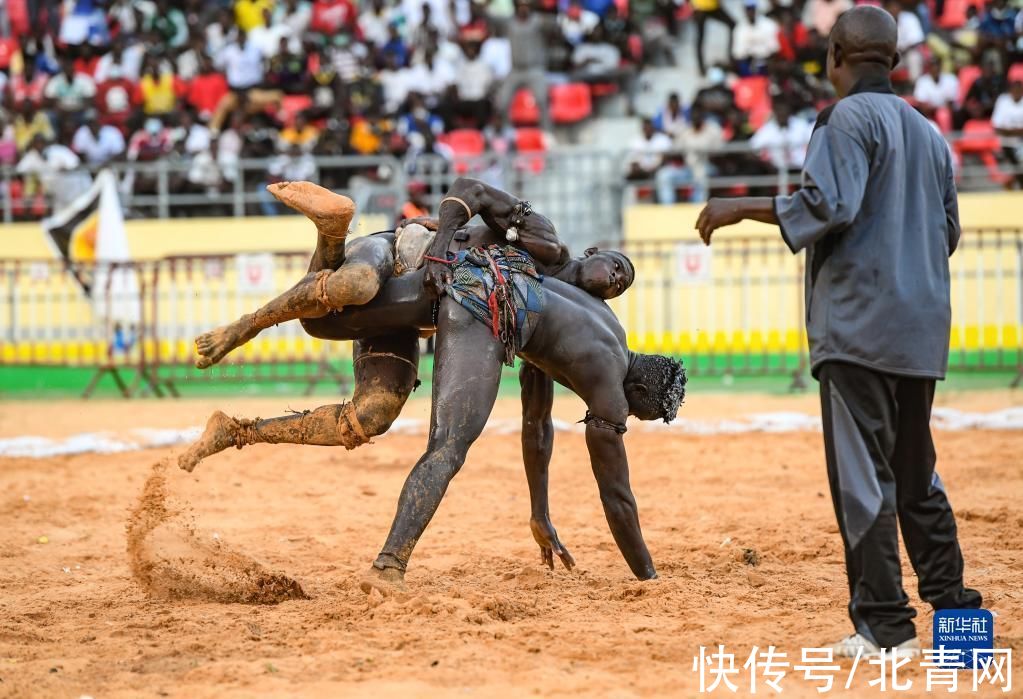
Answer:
[{"left": 0, "top": 0, "right": 1023, "bottom": 216}]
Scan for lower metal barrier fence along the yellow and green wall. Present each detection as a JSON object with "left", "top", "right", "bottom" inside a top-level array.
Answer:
[{"left": 0, "top": 228, "right": 1023, "bottom": 396}]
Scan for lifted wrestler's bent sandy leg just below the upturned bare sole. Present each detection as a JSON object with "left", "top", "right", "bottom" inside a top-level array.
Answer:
[{"left": 195, "top": 236, "right": 394, "bottom": 368}]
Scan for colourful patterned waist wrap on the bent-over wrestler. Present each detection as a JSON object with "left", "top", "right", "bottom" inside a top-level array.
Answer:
[{"left": 447, "top": 245, "right": 543, "bottom": 366}]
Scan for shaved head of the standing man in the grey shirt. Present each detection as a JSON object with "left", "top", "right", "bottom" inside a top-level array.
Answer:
[{"left": 828, "top": 5, "right": 899, "bottom": 97}]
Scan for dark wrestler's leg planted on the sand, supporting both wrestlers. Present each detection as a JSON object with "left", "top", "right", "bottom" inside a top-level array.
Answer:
[{"left": 361, "top": 299, "right": 504, "bottom": 594}]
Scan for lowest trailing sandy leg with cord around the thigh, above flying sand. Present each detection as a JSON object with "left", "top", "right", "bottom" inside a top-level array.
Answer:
[{"left": 178, "top": 330, "right": 419, "bottom": 471}]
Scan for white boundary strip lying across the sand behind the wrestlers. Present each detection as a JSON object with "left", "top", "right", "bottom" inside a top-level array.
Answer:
[{"left": 0, "top": 407, "right": 1023, "bottom": 458}]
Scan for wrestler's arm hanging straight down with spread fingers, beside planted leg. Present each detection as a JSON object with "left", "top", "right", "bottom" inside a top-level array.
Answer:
[{"left": 519, "top": 361, "right": 575, "bottom": 570}]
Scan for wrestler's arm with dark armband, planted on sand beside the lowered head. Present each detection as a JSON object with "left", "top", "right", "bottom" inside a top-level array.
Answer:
[{"left": 586, "top": 362, "right": 657, "bottom": 580}]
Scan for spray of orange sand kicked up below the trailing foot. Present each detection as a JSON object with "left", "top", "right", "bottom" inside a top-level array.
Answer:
[{"left": 127, "top": 462, "right": 307, "bottom": 604}]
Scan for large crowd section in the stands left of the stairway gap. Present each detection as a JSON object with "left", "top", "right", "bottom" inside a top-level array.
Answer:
[{"left": 0, "top": 0, "right": 664, "bottom": 214}]
